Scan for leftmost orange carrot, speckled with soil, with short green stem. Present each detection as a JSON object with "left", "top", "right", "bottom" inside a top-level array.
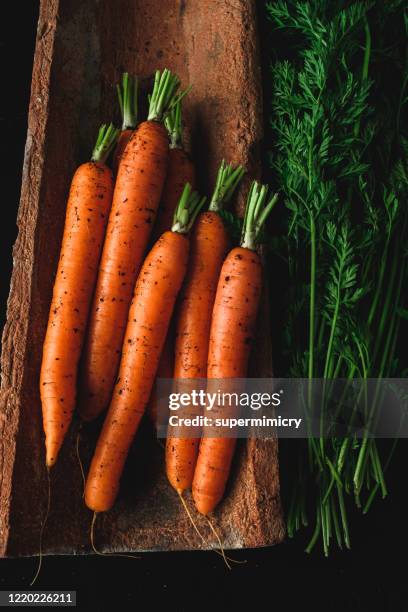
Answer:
[{"left": 40, "top": 124, "right": 119, "bottom": 467}]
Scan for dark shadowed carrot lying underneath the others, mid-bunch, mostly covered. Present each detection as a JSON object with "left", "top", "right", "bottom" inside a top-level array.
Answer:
[{"left": 147, "top": 100, "right": 195, "bottom": 424}]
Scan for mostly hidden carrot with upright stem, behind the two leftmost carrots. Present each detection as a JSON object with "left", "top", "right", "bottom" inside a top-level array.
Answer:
[{"left": 112, "top": 72, "right": 138, "bottom": 176}]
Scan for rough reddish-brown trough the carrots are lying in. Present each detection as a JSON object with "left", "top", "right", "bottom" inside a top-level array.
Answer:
[{"left": 0, "top": 0, "right": 284, "bottom": 556}]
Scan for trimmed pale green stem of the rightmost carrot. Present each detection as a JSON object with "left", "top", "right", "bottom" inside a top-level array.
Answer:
[{"left": 241, "top": 181, "right": 278, "bottom": 251}]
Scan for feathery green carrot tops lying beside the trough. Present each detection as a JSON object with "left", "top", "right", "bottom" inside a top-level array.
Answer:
[{"left": 265, "top": 0, "right": 408, "bottom": 554}]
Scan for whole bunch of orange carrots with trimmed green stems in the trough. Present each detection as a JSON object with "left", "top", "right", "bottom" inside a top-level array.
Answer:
[{"left": 40, "top": 69, "right": 276, "bottom": 515}]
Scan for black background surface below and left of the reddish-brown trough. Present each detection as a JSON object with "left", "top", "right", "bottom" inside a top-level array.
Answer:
[{"left": 0, "top": 0, "right": 408, "bottom": 612}]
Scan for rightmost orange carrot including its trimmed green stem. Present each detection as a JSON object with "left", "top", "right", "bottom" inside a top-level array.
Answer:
[{"left": 193, "top": 181, "right": 277, "bottom": 514}]
